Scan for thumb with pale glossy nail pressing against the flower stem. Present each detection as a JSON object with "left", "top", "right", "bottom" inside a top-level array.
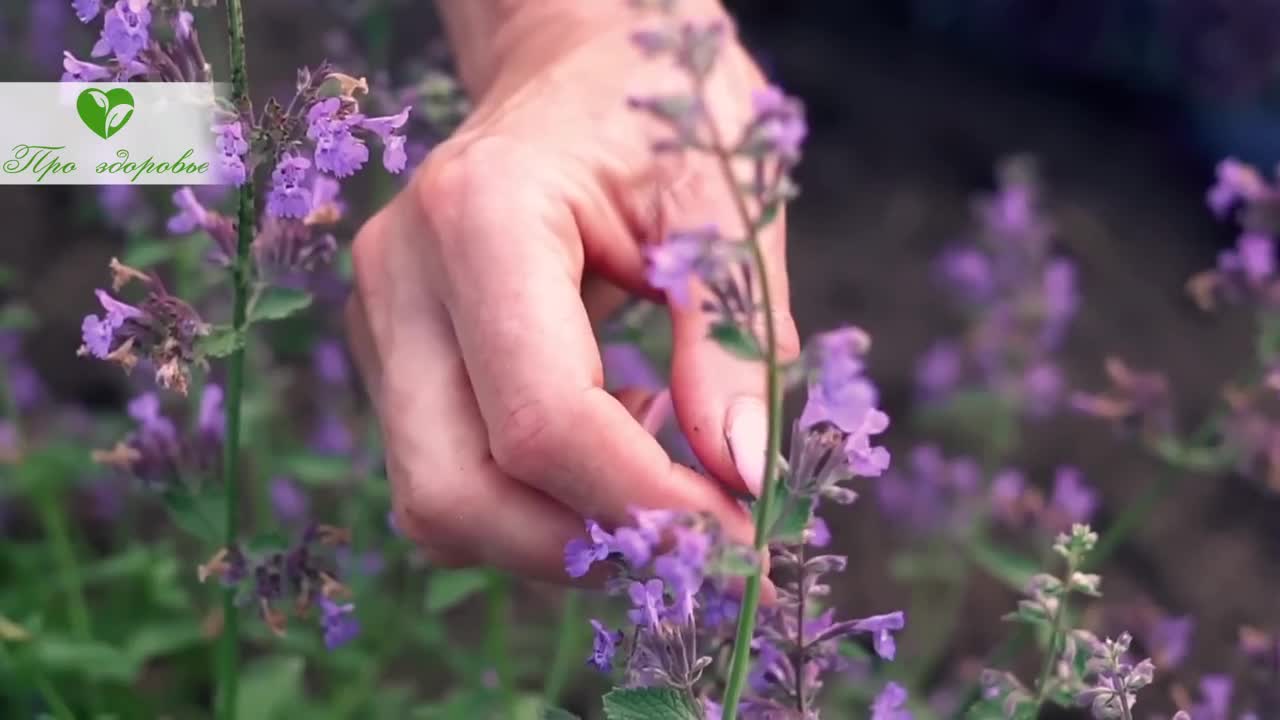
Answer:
[{"left": 669, "top": 193, "right": 800, "bottom": 497}]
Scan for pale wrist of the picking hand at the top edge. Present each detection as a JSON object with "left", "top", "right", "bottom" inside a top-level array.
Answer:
[{"left": 436, "top": 0, "right": 726, "bottom": 101}]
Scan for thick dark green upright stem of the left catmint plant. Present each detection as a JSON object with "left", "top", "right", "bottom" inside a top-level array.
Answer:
[{"left": 219, "top": 0, "right": 255, "bottom": 720}]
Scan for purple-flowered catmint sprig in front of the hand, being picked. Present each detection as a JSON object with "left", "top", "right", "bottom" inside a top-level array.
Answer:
[{"left": 555, "top": 3, "right": 905, "bottom": 720}]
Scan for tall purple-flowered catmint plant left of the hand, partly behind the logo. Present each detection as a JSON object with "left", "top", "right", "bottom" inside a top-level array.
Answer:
[{"left": 63, "top": 0, "right": 411, "bottom": 717}]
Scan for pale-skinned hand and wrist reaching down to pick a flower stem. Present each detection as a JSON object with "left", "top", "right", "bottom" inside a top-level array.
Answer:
[{"left": 347, "top": 0, "right": 799, "bottom": 582}]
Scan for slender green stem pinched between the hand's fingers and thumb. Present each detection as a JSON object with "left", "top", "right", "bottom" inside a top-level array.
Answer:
[{"left": 707, "top": 134, "right": 782, "bottom": 720}]
